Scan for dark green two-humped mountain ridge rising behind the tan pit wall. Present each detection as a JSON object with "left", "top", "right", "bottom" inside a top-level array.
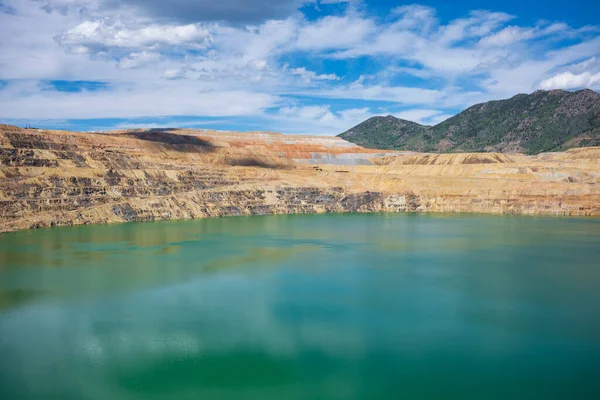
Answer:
[{"left": 338, "top": 89, "right": 600, "bottom": 154}]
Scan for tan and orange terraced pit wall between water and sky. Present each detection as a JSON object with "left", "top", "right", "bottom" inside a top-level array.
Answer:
[{"left": 0, "top": 125, "right": 600, "bottom": 232}]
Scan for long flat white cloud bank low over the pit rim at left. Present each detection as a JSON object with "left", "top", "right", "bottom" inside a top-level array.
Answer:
[{"left": 0, "top": 80, "right": 280, "bottom": 119}]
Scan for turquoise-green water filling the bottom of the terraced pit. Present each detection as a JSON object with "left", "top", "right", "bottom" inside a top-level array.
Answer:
[{"left": 0, "top": 214, "right": 600, "bottom": 400}]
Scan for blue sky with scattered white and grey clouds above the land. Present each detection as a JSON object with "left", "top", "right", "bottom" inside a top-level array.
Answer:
[{"left": 0, "top": 0, "right": 600, "bottom": 135}]
